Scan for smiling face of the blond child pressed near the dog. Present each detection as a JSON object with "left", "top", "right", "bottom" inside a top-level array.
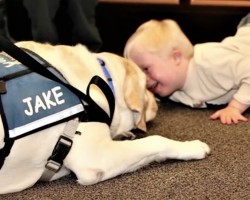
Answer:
[{"left": 129, "top": 47, "right": 178, "bottom": 97}]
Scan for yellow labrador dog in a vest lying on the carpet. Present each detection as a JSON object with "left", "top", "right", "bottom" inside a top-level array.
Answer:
[{"left": 0, "top": 41, "right": 210, "bottom": 194}]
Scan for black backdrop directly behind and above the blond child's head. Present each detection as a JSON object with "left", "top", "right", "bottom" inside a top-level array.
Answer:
[{"left": 96, "top": 2, "right": 250, "bottom": 53}]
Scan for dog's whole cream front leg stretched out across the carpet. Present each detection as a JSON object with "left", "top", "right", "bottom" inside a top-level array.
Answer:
[{"left": 67, "top": 126, "right": 210, "bottom": 185}]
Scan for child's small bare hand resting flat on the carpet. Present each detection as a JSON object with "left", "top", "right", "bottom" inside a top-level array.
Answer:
[{"left": 210, "top": 99, "right": 249, "bottom": 124}]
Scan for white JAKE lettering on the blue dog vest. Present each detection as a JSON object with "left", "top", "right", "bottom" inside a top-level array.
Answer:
[{"left": 23, "top": 86, "right": 65, "bottom": 116}]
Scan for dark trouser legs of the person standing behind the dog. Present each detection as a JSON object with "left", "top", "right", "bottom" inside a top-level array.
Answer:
[{"left": 23, "top": 0, "right": 102, "bottom": 51}]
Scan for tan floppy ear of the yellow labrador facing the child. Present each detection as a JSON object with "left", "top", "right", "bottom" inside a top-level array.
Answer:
[{"left": 123, "top": 60, "right": 147, "bottom": 132}]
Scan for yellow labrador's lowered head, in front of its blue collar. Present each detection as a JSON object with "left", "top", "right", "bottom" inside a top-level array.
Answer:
[{"left": 94, "top": 52, "right": 158, "bottom": 136}]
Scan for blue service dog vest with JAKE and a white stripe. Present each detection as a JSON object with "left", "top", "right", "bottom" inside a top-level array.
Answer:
[{"left": 0, "top": 52, "right": 84, "bottom": 138}]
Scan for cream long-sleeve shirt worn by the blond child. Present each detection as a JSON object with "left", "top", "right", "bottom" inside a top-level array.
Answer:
[{"left": 170, "top": 24, "right": 250, "bottom": 108}]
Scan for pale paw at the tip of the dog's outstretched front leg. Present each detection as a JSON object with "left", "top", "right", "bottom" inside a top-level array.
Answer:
[{"left": 178, "top": 140, "right": 211, "bottom": 160}]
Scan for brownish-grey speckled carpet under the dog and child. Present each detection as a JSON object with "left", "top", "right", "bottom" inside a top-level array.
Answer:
[{"left": 0, "top": 103, "right": 250, "bottom": 200}]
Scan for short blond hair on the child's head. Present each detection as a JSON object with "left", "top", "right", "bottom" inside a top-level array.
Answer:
[{"left": 124, "top": 19, "right": 193, "bottom": 59}]
